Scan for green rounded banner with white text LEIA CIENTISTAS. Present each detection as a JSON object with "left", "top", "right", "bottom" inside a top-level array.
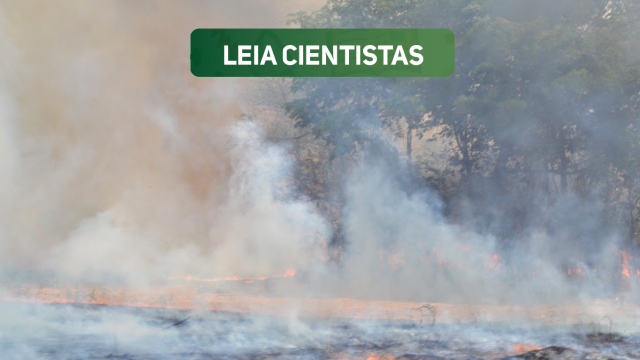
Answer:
[{"left": 191, "top": 29, "right": 455, "bottom": 77}]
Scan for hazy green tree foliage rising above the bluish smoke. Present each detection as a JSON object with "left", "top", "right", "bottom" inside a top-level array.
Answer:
[{"left": 288, "top": 0, "right": 640, "bottom": 242}]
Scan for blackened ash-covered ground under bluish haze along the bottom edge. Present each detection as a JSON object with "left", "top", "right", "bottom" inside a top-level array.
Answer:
[{"left": 0, "top": 302, "right": 640, "bottom": 360}]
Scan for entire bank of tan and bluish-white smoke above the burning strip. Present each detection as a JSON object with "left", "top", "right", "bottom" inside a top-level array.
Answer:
[{"left": 0, "top": 1, "right": 636, "bottom": 316}]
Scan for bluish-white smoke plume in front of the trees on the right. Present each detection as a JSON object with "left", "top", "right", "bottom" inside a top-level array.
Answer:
[{"left": 341, "top": 152, "right": 621, "bottom": 303}]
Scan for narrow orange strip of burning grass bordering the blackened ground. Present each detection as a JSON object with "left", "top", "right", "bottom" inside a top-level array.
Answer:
[{"left": 4, "top": 285, "right": 640, "bottom": 331}]
